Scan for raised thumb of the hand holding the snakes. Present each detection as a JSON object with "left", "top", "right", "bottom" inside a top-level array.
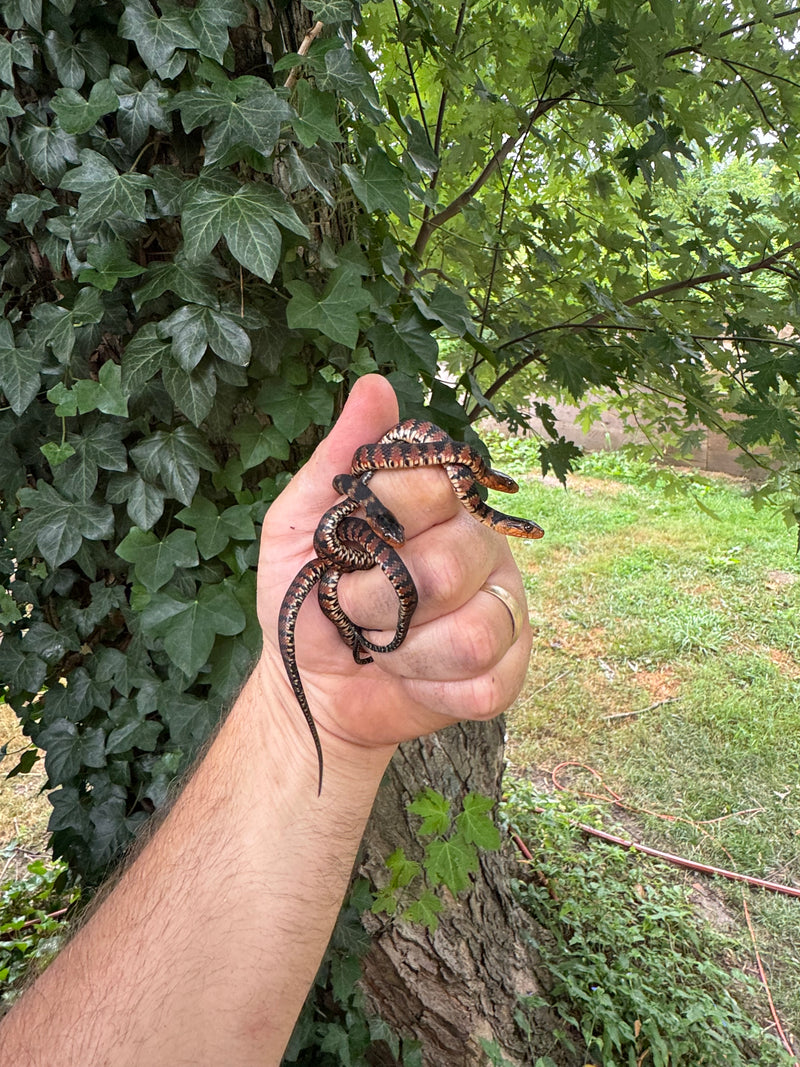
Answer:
[{"left": 267, "top": 375, "right": 399, "bottom": 525}]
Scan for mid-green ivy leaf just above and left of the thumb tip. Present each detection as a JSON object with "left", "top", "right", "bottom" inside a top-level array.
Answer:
[{"left": 286, "top": 265, "right": 369, "bottom": 349}]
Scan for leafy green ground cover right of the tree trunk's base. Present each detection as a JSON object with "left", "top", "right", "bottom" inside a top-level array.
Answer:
[{"left": 506, "top": 782, "right": 793, "bottom": 1067}]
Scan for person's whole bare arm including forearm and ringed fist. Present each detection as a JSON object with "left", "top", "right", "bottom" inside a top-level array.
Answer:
[{"left": 0, "top": 376, "right": 530, "bottom": 1067}]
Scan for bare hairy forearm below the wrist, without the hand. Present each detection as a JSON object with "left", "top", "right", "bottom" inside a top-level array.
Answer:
[{"left": 0, "top": 665, "right": 391, "bottom": 1067}]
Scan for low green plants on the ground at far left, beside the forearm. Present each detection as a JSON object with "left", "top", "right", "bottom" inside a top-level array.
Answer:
[{"left": 0, "top": 843, "right": 79, "bottom": 1014}]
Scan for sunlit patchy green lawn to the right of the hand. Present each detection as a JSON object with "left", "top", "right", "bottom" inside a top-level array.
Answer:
[{"left": 496, "top": 446, "right": 800, "bottom": 1058}]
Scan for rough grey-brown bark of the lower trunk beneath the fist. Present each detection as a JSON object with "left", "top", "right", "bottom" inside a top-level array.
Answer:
[{"left": 359, "top": 720, "right": 585, "bottom": 1067}]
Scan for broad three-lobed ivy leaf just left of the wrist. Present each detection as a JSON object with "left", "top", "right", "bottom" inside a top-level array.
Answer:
[{"left": 142, "top": 585, "right": 246, "bottom": 678}]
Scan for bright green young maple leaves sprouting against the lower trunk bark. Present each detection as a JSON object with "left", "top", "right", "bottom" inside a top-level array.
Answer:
[{"left": 371, "top": 789, "right": 500, "bottom": 933}]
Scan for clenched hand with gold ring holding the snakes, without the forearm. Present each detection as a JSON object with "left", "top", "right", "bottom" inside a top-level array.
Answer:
[{"left": 259, "top": 375, "right": 531, "bottom": 750}]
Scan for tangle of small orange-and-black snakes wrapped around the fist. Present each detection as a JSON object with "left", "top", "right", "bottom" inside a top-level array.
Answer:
[{"left": 277, "top": 419, "right": 544, "bottom": 792}]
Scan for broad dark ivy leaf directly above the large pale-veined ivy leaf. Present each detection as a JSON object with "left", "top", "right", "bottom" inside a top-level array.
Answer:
[{"left": 172, "top": 78, "right": 292, "bottom": 166}]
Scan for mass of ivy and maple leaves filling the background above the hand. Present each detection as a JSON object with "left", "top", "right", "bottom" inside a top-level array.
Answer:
[{"left": 0, "top": 0, "right": 800, "bottom": 878}]
